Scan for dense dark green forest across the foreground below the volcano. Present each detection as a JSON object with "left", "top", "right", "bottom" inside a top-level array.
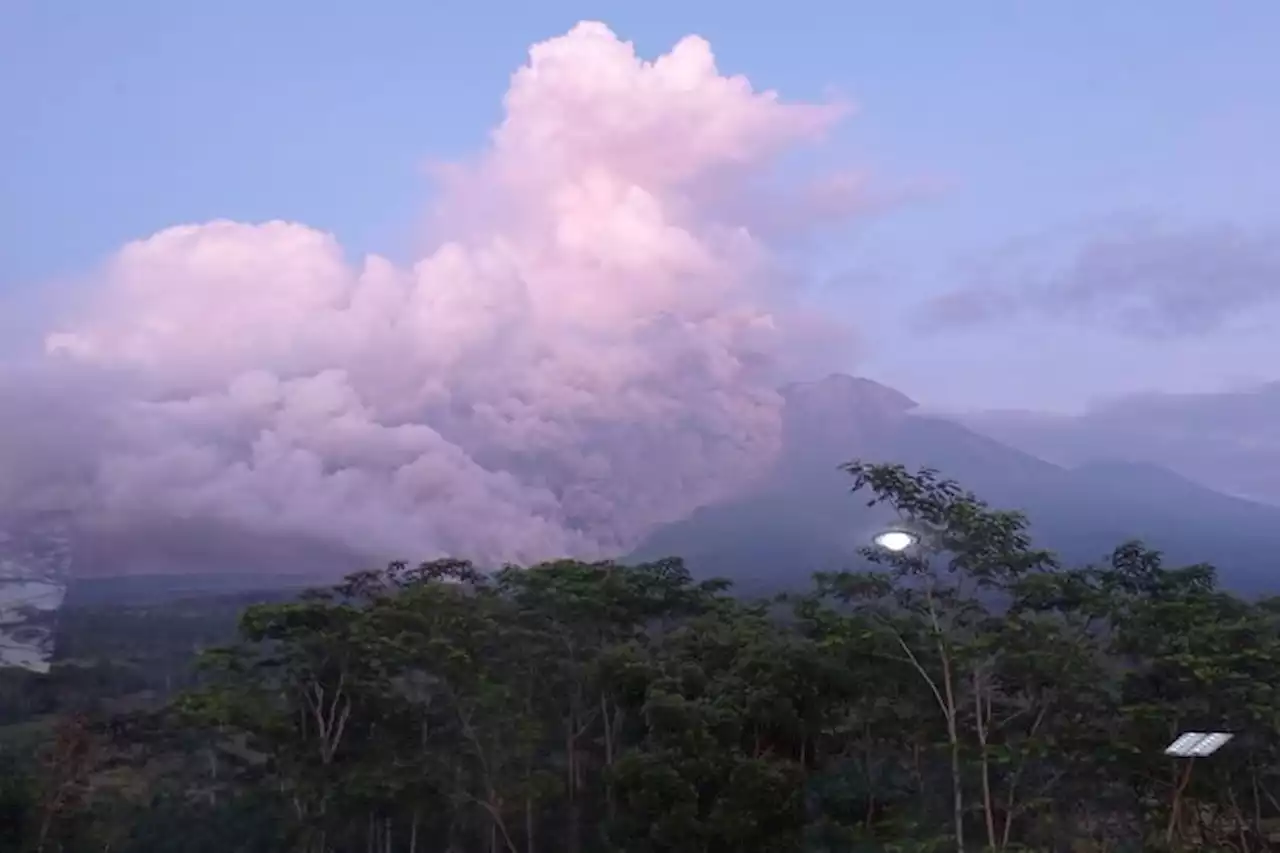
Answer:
[{"left": 0, "top": 462, "right": 1280, "bottom": 853}]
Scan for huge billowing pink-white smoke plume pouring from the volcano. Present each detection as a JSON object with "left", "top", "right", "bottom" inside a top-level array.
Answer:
[{"left": 6, "top": 24, "right": 860, "bottom": 571}]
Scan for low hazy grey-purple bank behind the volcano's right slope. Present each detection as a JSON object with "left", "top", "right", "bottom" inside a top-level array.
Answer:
[{"left": 950, "top": 382, "right": 1280, "bottom": 505}]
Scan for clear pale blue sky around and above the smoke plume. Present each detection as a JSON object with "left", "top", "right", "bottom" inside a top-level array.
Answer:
[{"left": 0, "top": 0, "right": 1280, "bottom": 407}]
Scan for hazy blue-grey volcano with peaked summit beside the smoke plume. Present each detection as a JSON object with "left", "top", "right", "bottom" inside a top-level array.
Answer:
[{"left": 632, "top": 375, "right": 1280, "bottom": 592}]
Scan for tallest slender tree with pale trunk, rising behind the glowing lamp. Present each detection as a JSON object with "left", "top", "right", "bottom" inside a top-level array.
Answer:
[{"left": 819, "top": 461, "right": 1056, "bottom": 853}]
